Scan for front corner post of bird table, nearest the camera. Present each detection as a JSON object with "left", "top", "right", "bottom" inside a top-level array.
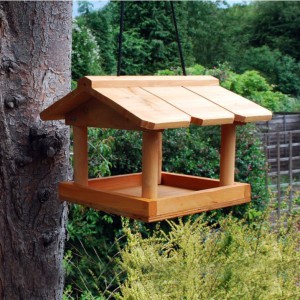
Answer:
[{"left": 142, "top": 131, "right": 161, "bottom": 199}]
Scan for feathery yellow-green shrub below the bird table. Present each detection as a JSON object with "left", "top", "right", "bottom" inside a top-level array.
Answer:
[{"left": 117, "top": 215, "right": 300, "bottom": 300}]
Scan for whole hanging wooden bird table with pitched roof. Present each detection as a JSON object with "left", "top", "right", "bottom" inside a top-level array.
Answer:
[{"left": 41, "top": 76, "right": 272, "bottom": 222}]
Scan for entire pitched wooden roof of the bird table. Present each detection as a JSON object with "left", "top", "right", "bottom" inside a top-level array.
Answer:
[{"left": 41, "top": 76, "right": 272, "bottom": 130}]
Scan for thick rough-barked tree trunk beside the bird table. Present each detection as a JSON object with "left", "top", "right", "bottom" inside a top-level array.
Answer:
[{"left": 0, "top": 1, "right": 71, "bottom": 300}]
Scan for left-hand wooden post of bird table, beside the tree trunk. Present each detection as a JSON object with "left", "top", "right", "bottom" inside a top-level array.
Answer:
[{"left": 73, "top": 126, "right": 88, "bottom": 186}]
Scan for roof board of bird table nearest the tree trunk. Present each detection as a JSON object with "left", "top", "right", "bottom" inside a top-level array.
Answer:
[{"left": 92, "top": 87, "right": 190, "bottom": 130}]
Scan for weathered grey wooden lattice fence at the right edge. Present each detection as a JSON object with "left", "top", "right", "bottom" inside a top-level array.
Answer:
[{"left": 258, "top": 114, "right": 300, "bottom": 215}]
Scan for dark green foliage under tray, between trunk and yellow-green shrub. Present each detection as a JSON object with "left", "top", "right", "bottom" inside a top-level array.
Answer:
[{"left": 65, "top": 205, "right": 121, "bottom": 300}]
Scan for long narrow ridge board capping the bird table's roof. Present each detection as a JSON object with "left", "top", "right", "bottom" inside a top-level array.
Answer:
[{"left": 78, "top": 76, "right": 219, "bottom": 88}]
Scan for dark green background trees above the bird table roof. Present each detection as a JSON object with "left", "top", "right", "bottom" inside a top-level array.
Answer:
[{"left": 72, "top": 1, "right": 300, "bottom": 96}]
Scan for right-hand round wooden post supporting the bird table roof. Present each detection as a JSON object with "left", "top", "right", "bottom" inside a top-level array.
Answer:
[{"left": 220, "top": 124, "right": 236, "bottom": 186}]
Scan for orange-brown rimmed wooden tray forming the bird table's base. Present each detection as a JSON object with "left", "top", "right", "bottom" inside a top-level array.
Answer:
[{"left": 59, "top": 172, "right": 251, "bottom": 222}]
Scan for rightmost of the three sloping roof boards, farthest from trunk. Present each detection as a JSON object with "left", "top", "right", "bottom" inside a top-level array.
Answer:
[{"left": 185, "top": 86, "right": 272, "bottom": 123}]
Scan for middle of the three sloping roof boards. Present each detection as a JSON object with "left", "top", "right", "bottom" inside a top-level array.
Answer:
[{"left": 144, "top": 86, "right": 234, "bottom": 125}]
